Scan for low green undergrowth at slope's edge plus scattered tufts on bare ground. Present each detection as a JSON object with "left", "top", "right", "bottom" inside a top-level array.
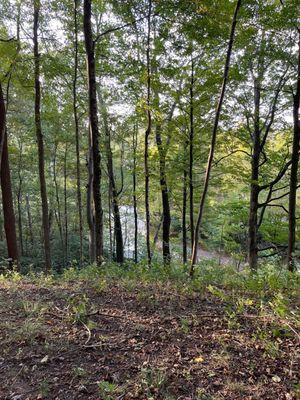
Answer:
[{"left": 0, "top": 261, "right": 300, "bottom": 366}]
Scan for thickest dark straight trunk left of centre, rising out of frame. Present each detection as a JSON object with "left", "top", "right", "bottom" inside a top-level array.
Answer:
[{"left": 83, "top": 0, "right": 103, "bottom": 263}]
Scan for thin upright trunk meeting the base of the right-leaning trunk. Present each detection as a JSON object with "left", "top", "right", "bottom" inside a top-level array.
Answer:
[{"left": 189, "top": 58, "right": 195, "bottom": 246}]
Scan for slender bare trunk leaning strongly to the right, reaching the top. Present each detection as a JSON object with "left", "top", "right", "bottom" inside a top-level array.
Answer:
[{"left": 190, "top": 0, "right": 242, "bottom": 276}]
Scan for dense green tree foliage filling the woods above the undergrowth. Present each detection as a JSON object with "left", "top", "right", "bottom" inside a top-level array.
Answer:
[{"left": 0, "top": 0, "right": 300, "bottom": 271}]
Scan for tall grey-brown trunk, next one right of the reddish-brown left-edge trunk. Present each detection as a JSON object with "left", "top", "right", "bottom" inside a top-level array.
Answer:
[{"left": 33, "top": 0, "right": 51, "bottom": 273}]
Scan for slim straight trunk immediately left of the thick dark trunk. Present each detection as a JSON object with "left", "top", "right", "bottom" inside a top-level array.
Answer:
[{"left": 73, "top": 0, "right": 83, "bottom": 264}]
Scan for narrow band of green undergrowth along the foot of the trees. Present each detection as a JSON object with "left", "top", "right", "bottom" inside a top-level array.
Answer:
[{"left": 0, "top": 261, "right": 300, "bottom": 299}]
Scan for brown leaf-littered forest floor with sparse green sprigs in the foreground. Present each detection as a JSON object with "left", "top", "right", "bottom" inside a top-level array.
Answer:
[{"left": 0, "top": 264, "right": 300, "bottom": 400}]
